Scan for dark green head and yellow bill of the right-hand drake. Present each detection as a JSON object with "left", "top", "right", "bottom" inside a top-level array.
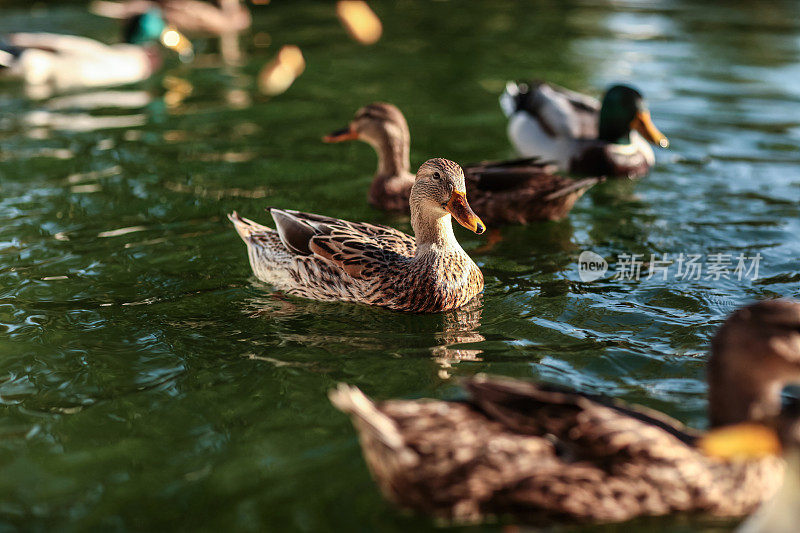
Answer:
[{"left": 598, "top": 85, "right": 669, "bottom": 148}]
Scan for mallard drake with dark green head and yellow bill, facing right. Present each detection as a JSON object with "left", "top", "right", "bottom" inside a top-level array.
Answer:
[{"left": 500, "top": 82, "right": 669, "bottom": 178}]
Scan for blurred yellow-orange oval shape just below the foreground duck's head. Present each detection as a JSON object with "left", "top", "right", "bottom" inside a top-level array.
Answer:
[{"left": 697, "top": 423, "right": 781, "bottom": 461}]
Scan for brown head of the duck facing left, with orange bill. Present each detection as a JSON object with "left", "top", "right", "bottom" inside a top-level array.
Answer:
[{"left": 322, "top": 102, "right": 411, "bottom": 175}]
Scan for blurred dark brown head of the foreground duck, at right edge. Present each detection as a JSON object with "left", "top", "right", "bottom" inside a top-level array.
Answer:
[{"left": 707, "top": 300, "right": 800, "bottom": 427}]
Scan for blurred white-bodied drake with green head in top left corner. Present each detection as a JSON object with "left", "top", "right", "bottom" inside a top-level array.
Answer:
[{"left": 0, "top": 9, "right": 192, "bottom": 91}]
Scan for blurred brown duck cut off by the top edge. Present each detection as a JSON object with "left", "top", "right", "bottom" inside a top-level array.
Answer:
[{"left": 89, "top": 0, "right": 252, "bottom": 35}]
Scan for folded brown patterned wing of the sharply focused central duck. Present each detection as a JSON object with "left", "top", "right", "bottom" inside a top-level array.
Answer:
[{"left": 270, "top": 209, "right": 416, "bottom": 279}]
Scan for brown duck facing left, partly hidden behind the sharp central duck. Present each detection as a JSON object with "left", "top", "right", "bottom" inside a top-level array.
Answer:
[{"left": 323, "top": 102, "right": 600, "bottom": 224}]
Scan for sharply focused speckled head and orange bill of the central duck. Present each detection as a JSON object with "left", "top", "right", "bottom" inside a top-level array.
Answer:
[{"left": 409, "top": 158, "right": 486, "bottom": 243}]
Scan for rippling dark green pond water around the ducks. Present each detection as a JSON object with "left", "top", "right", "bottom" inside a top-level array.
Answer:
[{"left": 0, "top": 0, "right": 800, "bottom": 531}]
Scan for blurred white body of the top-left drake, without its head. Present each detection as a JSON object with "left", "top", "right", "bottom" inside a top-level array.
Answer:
[{"left": 4, "top": 33, "right": 155, "bottom": 91}]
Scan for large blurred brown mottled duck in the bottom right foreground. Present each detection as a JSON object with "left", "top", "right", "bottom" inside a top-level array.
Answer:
[{"left": 331, "top": 300, "right": 800, "bottom": 521}]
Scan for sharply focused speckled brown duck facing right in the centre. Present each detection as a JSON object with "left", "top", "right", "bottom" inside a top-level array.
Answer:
[{"left": 229, "top": 158, "right": 485, "bottom": 312}]
